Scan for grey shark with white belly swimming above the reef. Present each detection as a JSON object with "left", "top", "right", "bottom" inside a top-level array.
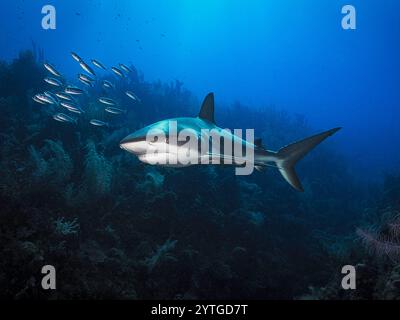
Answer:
[{"left": 120, "top": 93, "right": 341, "bottom": 192}]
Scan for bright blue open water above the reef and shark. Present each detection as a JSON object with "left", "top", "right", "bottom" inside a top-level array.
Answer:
[{"left": 0, "top": 0, "right": 400, "bottom": 177}]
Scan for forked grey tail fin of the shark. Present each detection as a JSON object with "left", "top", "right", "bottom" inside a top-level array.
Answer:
[{"left": 276, "top": 128, "right": 341, "bottom": 191}]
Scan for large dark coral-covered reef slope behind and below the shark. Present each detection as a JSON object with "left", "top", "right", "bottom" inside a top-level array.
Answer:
[{"left": 0, "top": 52, "right": 388, "bottom": 299}]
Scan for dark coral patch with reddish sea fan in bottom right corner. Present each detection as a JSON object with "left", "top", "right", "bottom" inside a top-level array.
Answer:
[{"left": 302, "top": 174, "right": 400, "bottom": 300}]
